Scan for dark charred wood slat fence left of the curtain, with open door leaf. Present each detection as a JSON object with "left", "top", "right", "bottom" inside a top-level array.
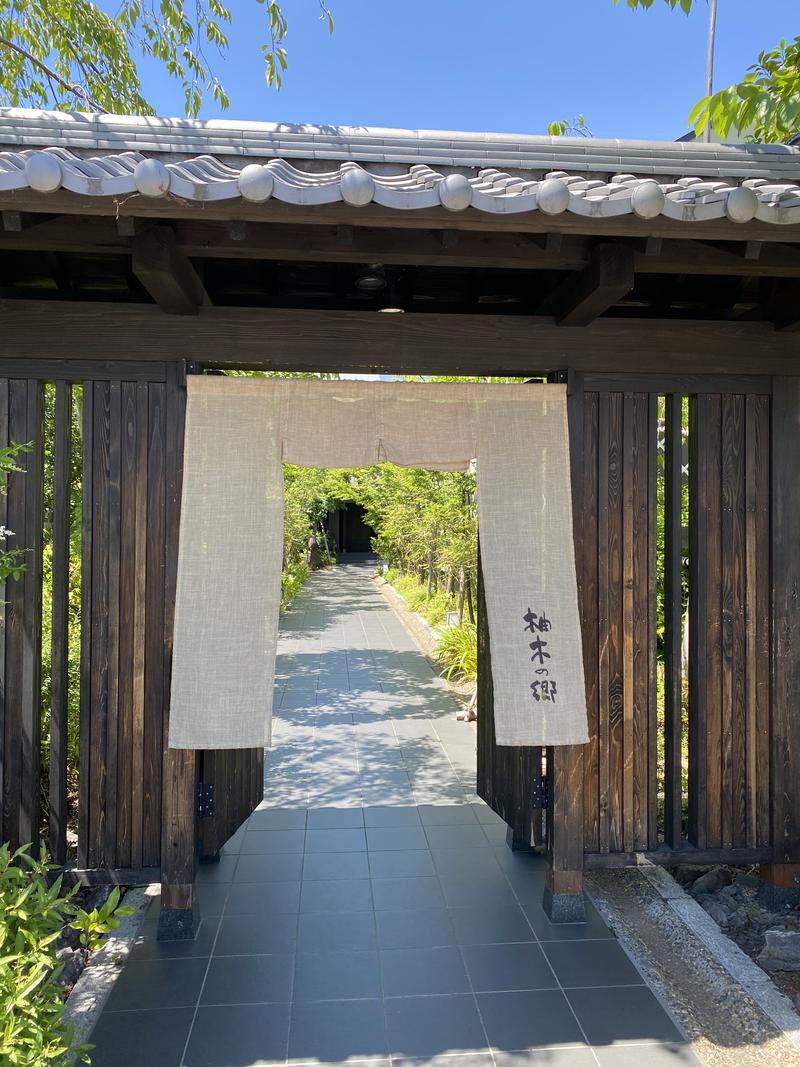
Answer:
[{"left": 0, "top": 361, "right": 263, "bottom": 882}]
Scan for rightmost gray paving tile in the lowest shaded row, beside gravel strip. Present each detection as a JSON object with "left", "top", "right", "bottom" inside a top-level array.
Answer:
[{"left": 566, "top": 986, "right": 683, "bottom": 1046}]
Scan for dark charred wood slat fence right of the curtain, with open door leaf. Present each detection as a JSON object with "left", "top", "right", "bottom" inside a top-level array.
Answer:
[{"left": 478, "top": 375, "right": 800, "bottom": 883}]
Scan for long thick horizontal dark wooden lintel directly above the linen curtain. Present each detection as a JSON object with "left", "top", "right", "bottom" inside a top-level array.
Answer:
[{"left": 0, "top": 300, "right": 800, "bottom": 376}]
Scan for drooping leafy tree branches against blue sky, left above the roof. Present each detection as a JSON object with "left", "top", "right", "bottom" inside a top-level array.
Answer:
[{"left": 0, "top": 0, "right": 333, "bottom": 117}]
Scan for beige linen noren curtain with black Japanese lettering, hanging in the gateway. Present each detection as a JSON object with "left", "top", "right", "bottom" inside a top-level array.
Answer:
[{"left": 170, "top": 376, "right": 588, "bottom": 749}]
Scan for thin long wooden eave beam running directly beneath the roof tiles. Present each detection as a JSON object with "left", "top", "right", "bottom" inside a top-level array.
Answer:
[{"left": 0, "top": 189, "right": 800, "bottom": 243}]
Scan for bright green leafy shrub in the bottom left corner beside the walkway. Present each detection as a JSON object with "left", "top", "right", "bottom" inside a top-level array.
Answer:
[{"left": 0, "top": 845, "right": 86, "bottom": 1067}]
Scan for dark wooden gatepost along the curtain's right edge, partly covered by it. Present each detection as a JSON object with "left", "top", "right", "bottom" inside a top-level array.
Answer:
[{"left": 543, "top": 371, "right": 586, "bottom": 923}]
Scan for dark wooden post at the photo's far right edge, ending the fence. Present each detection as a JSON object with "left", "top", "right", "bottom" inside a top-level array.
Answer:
[{"left": 761, "top": 378, "right": 800, "bottom": 907}]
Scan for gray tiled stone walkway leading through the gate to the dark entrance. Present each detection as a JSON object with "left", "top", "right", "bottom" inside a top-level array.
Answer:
[{"left": 92, "top": 564, "right": 699, "bottom": 1067}]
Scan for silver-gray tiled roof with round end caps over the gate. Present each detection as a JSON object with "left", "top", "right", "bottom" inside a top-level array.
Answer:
[{"left": 0, "top": 109, "right": 800, "bottom": 224}]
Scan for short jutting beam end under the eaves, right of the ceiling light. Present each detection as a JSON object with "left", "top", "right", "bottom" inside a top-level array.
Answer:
[{"left": 545, "top": 244, "right": 635, "bottom": 327}]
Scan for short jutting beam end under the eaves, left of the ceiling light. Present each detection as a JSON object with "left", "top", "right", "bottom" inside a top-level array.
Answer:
[{"left": 131, "top": 226, "right": 210, "bottom": 315}]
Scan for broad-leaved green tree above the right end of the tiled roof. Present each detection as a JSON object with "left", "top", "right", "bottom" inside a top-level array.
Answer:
[{"left": 614, "top": 0, "right": 800, "bottom": 143}]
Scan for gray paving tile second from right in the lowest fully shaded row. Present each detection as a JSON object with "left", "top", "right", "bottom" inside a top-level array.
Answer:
[{"left": 478, "top": 989, "right": 586, "bottom": 1051}]
